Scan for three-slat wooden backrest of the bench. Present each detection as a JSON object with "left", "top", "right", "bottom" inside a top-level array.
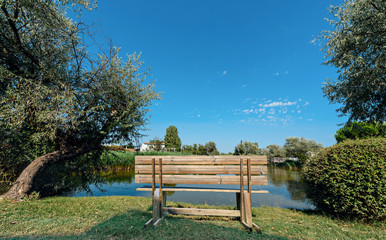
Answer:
[{"left": 135, "top": 156, "right": 267, "bottom": 185}]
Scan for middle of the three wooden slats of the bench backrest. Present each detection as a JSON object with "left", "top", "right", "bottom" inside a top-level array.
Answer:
[{"left": 135, "top": 164, "right": 267, "bottom": 175}]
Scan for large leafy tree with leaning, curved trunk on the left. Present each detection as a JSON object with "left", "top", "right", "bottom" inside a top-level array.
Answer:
[{"left": 0, "top": 0, "right": 159, "bottom": 200}]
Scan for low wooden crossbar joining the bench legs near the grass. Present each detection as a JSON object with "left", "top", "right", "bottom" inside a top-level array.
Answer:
[{"left": 164, "top": 207, "right": 240, "bottom": 217}]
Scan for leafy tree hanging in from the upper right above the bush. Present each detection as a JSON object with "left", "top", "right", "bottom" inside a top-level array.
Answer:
[{"left": 321, "top": 0, "right": 386, "bottom": 122}]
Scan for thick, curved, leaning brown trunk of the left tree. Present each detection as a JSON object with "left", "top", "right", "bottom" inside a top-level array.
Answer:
[{"left": 0, "top": 148, "right": 93, "bottom": 201}]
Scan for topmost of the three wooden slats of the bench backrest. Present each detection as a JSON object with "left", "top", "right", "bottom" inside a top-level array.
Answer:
[{"left": 135, "top": 156, "right": 267, "bottom": 165}]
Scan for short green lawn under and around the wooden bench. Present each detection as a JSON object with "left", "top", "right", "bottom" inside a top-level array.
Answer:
[{"left": 0, "top": 197, "right": 386, "bottom": 239}]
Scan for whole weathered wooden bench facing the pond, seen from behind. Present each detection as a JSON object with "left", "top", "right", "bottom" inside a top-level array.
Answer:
[{"left": 135, "top": 156, "right": 268, "bottom": 232}]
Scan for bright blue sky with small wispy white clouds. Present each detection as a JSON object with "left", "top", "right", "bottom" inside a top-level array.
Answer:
[{"left": 83, "top": 0, "right": 346, "bottom": 152}]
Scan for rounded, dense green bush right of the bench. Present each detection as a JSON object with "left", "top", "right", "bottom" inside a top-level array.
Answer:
[{"left": 303, "top": 138, "right": 386, "bottom": 221}]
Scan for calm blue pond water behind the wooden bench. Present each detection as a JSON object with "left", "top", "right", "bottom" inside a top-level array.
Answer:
[{"left": 66, "top": 167, "right": 314, "bottom": 209}]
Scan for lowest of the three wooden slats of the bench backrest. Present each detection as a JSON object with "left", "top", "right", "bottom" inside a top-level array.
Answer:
[{"left": 135, "top": 174, "right": 267, "bottom": 185}]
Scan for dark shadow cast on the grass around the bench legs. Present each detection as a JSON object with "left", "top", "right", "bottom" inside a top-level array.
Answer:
[{"left": 7, "top": 210, "right": 285, "bottom": 239}]
